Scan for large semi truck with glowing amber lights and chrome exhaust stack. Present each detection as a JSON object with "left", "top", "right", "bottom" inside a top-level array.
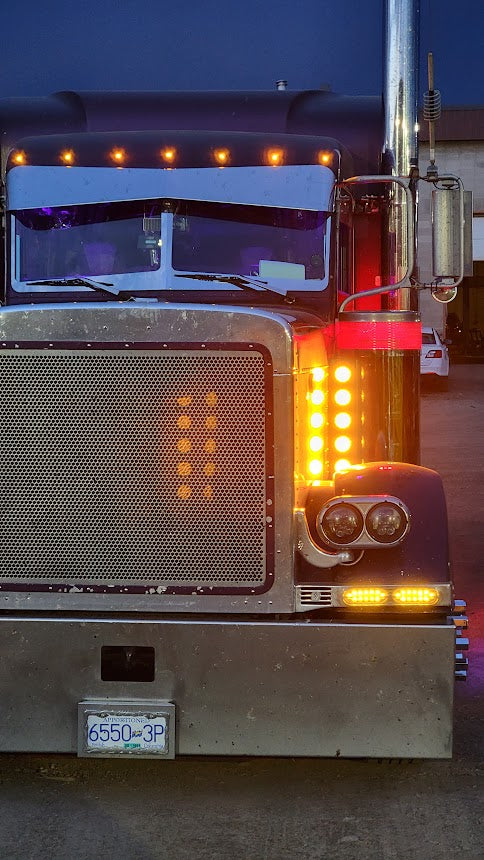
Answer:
[{"left": 0, "top": 0, "right": 468, "bottom": 759}]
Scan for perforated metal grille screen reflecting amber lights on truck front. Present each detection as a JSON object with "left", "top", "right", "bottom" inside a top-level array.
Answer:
[{"left": 0, "top": 350, "right": 267, "bottom": 591}]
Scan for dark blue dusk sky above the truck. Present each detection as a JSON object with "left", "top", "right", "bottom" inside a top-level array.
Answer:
[{"left": 0, "top": 0, "right": 484, "bottom": 105}]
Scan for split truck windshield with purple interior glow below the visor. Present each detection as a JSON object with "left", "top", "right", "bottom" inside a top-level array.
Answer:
[{"left": 14, "top": 200, "right": 328, "bottom": 292}]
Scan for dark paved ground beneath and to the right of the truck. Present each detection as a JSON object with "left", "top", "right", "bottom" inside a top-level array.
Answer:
[{"left": 0, "top": 365, "right": 484, "bottom": 860}]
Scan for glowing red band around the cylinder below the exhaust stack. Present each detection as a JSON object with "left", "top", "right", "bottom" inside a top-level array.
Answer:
[{"left": 336, "top": 320, "right": 422, "bottom": 350}]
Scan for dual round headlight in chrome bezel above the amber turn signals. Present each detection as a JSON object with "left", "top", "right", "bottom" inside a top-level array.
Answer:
[{"left": 317, "top": 498, "right": 410, "bottom": 547}]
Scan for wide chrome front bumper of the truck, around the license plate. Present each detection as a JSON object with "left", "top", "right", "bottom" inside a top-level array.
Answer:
[{"left": 0, "top": 616, "right": 455, "bottom": 758}]
